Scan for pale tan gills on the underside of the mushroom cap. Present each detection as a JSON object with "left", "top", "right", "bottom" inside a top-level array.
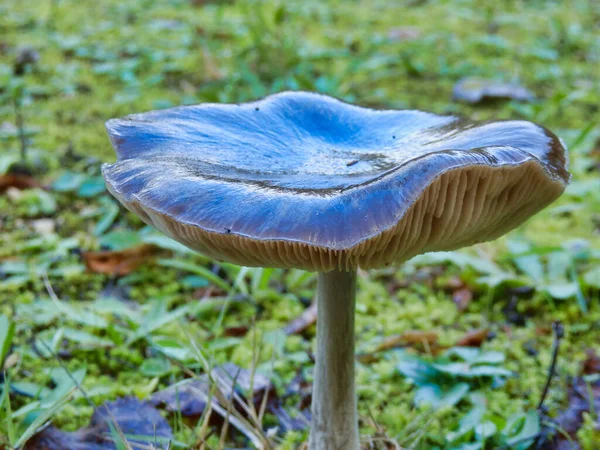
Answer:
[{"left": 108, "top": 161, "right": 564, "bottom": 272}]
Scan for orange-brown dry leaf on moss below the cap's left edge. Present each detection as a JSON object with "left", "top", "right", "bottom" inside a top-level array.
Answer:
[{"left": 81, "top": 244, "right": 158, "bottom": 275}]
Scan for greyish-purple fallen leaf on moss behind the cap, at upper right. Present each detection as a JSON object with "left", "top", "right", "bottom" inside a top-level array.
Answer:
[{"left": 452, "top": 78, "right": 533, "bottom": 104}]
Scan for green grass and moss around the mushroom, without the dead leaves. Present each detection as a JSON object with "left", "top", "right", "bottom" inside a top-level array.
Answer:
[{"left": 0, "top": 0, "right": 600, "bottom": 450}]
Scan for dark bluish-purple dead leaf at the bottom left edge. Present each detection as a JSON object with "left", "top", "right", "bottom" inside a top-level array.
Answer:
[{"left": 24, "top": 397, "right": 173, "bottom": 450}]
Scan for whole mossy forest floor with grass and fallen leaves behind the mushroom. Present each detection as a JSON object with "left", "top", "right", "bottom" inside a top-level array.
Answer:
[{"left": 0, "top": 0, "right": 600, "bottom": 450}]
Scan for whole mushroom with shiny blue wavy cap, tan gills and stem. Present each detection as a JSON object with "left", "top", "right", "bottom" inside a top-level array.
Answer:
[{"left": 103, "top": 92, "right": 570, "bottom": 450}]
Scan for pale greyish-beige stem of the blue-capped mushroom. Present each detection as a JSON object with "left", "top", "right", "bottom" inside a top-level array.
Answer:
[{"left": 308, "top": 270, "right": 360, "bottom": 450}]
